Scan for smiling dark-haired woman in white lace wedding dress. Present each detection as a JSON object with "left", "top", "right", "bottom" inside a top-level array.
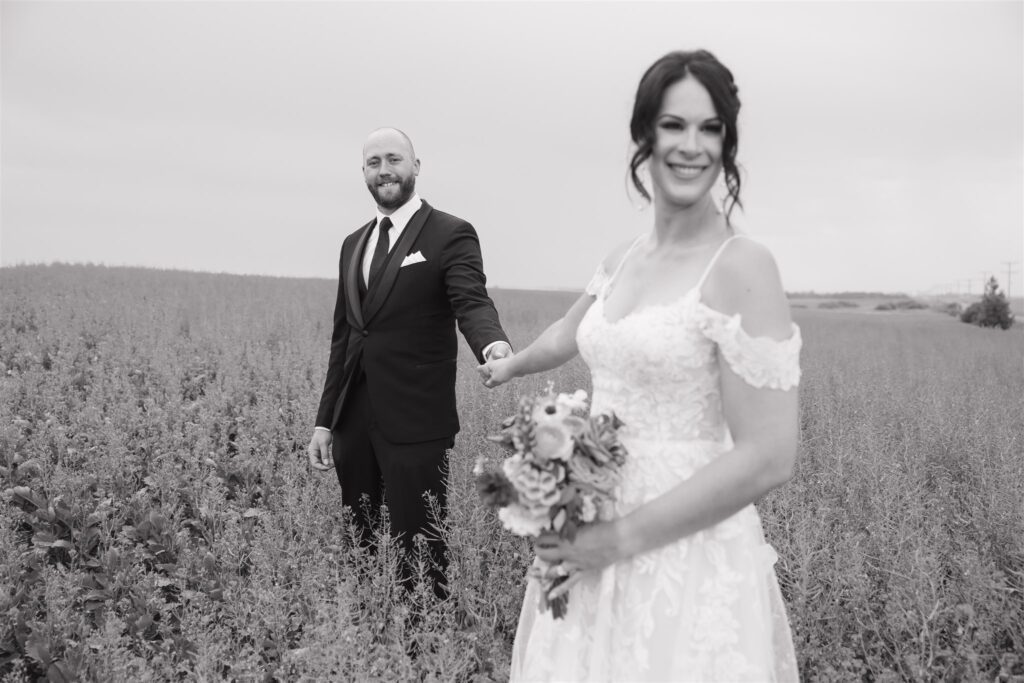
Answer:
[{"left": 479, "top": 50, "right": 801, "bottom": 681}]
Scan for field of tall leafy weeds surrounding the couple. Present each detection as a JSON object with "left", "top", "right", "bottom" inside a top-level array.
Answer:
[{"left": 0, "top": 266, "right": 1024, "bottom": 681}]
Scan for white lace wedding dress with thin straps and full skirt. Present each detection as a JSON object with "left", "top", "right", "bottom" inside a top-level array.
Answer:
[{"left": 511, "top": 236, "right": 801, "bottom": 682}]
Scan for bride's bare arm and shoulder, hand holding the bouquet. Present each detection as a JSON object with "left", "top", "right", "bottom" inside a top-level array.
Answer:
[{"left": 538, "top": 240, "right": 799, "bottom": 568}]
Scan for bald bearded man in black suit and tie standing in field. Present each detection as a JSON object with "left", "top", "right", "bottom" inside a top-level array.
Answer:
[{"left": 307, "top": 128, "right": 512, "bottom": 595}]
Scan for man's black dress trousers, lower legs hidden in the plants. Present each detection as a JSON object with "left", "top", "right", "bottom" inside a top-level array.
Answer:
[{"left": 331, "top": 373, "right": 455, "bottom": 597}]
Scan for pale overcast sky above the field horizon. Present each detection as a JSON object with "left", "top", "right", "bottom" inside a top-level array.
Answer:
[{"left": 0, "top": 0, "right": 1024, "bottom": 295}]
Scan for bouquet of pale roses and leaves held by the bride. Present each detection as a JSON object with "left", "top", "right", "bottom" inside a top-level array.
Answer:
[{"left": 474, "top": 385, "right": 626, "bottom": 618}]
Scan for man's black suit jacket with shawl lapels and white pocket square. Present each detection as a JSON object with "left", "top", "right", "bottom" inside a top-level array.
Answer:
[{"left": 316, "top": 202, "right": 508, "bottom": 443}]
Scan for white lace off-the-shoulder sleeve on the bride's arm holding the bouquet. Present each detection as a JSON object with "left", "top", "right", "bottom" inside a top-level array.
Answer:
[{"left": 700, "top": 306, "right": 803, "bottom": 389}]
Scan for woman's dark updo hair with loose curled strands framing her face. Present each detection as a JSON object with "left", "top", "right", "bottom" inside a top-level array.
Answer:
[{"left": 630, "top": 50, "right": 743, "bottom": 221}]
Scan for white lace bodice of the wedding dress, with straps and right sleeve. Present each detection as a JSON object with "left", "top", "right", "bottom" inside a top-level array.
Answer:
[{"left": 577, "top": 238, "right": 802, "bottom": 448}]
